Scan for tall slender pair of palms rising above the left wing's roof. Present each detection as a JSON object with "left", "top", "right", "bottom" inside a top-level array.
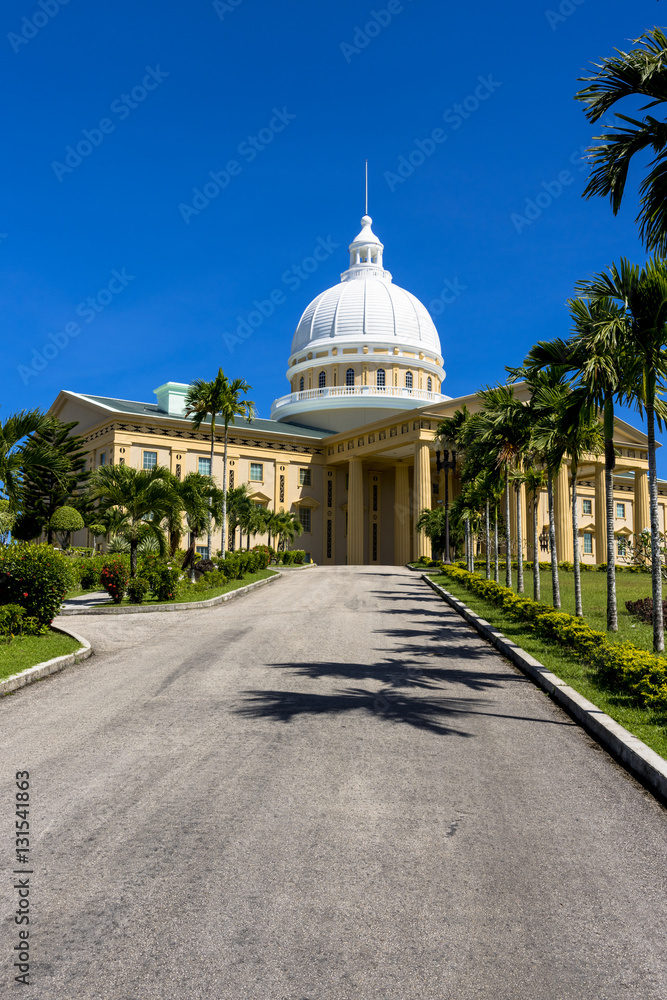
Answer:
[{"left": 185, "top": 368, "right": 255, "bottom": 558}]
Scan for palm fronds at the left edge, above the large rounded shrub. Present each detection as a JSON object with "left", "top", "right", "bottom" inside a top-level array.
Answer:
[{"left": 0, "top": 410, "right": 66, "bottom": 510}]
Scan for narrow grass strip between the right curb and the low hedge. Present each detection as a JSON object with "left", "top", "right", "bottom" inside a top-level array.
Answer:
[{"left": 433, "top": 574, "right": 667, "bottom": 759}]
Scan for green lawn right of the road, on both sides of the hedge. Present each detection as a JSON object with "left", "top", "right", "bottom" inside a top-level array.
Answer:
[{"left": 433, "top": 572, "right": 667, "bottom": 758}]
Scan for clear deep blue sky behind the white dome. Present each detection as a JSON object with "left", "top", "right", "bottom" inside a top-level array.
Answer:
[{"left": 0, "top": 0, "right": 667, "bottom": 476}]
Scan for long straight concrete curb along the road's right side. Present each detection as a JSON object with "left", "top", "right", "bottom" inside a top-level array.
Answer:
[{"left": 422, "top": 573, "right": 667, "bottom": 800}]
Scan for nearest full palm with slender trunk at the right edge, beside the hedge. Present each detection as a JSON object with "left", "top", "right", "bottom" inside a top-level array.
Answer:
[{"left": 577, "top": 257, "right": 667, "bottom": 653}]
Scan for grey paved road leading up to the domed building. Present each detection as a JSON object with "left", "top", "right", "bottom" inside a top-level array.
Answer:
[{"left": 0, "top": 567, "right": 667, "bottom": 1000}]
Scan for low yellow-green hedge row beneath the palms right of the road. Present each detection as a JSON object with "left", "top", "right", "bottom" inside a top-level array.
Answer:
[{"left": 442, "top": 566, "right": 667, "bottom": 711}]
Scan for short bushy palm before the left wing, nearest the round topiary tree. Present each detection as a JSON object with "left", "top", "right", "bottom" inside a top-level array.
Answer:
[{"left": 89, "top": 465, "right": 182, "bottom": 577}]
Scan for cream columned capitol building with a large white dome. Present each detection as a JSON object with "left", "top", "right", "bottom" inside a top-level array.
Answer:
[{"left": 49, "top": 215, "right": 667, "bottom": 565}]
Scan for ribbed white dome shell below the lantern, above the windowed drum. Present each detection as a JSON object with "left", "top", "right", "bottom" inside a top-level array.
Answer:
[{"left": 292, "top": 271, "right": 440, "bottom": 355}]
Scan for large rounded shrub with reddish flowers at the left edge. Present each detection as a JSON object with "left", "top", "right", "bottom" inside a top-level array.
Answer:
[{"left": 0, "top": 542, "right": 77, "bottom": 625}]
